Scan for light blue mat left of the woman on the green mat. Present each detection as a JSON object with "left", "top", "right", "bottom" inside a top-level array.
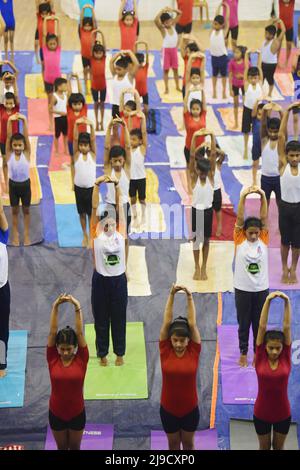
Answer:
[{"left": 55, "top": 204, "right": 82, "bottom": 248}]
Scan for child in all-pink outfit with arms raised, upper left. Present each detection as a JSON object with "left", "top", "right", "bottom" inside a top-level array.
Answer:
[{"left": 42, "top": 16, "right": 61, "bottom": 131}]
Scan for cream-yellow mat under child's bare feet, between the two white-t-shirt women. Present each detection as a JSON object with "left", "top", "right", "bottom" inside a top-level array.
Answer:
[{"left": 176, "top": 241, "right": 234, "bottom": 293}]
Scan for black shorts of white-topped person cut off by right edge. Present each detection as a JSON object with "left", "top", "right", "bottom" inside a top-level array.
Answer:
[{"left": 279, "top": 201, "right": 300, "bottom": 249}]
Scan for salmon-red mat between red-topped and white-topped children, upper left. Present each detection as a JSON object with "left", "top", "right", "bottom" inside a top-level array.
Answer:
[{"left": 28, "top": 99, "right": 53, "bottom": 135}]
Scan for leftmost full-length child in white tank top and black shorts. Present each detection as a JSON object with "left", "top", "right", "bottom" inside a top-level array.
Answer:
[{"left": 6, "top": 113, "right": 31, "bottom": 246}]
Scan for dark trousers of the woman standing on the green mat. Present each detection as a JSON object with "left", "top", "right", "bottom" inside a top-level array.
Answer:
[{"left": 92, "top": 271, "right": 128, "bottom": 357}]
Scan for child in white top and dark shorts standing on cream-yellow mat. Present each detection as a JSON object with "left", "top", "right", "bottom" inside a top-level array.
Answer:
[{"left": 189, "top": 129, "right": 216, "bottom": 281}]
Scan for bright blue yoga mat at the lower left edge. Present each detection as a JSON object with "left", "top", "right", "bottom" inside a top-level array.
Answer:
[{"left": 0, "top": 330, "right": 27, "bottom": 408}]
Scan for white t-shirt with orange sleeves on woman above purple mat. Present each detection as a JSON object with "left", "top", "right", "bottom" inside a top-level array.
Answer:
[{"left": 233, "top": 229, "right": 269, "bottom": 292}]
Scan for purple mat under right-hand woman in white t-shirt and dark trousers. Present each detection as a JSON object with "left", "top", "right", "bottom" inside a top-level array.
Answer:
[{"left": 218, "top": 325, "right": 257, "bottom": 405}]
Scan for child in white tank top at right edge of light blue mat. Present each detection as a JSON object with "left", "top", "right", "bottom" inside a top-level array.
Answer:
[{"left": 73, "top": 117, "right": 97, "bottom": 248}]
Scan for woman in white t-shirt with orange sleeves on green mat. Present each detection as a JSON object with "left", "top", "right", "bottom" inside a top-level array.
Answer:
[{"left": 91, "top": 175, "right": 128, "bottom": 366}]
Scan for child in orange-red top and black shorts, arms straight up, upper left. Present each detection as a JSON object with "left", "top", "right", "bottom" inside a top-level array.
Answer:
[{"left": 91, "top": 29, "right": 106, "bottom": 131}]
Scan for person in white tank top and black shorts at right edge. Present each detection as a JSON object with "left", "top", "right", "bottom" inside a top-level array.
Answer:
[{"left": 278, "top": 101, "right": 300, "bottom": 284}]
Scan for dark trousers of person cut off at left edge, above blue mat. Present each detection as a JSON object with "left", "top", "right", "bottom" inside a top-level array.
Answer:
[{"left": 0, "top": 282, "right": 10, "bottom": 370}]
